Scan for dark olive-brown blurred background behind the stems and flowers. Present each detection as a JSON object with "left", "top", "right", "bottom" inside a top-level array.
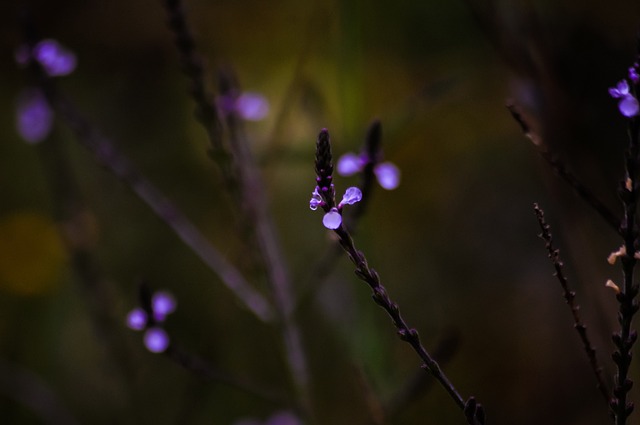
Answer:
[{"left": 0, "top": 0, "right": 640, "bottom": 425}]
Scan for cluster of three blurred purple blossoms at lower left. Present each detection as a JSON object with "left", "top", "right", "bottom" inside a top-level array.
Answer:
[{"left": 127, "top": 291, "right": 176, "bottom": 353}]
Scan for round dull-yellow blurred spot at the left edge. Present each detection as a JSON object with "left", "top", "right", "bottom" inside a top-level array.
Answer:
[{"left": 0, "top": 211, "right": 66, "bottom": 295}]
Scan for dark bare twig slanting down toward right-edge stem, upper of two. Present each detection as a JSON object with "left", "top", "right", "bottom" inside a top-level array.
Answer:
[{"left": 507, "top": 104, "right": 620, "bottom": 233}]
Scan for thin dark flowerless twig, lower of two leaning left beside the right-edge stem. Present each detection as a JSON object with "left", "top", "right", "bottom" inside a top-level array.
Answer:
[{"left": 533, "top": 204, "right": 611, "bottom": 404}]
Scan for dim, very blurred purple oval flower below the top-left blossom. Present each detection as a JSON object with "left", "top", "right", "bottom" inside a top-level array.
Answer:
[{"left": 16, "top": 88, "right": 53, "bottom": 143}]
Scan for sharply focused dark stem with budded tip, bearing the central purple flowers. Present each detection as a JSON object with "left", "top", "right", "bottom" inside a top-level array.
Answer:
[{"left": 315, "top": 129, "right": 484, "bottom": 425}]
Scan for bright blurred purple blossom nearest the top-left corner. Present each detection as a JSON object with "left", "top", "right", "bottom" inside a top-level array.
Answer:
[{"left": 16, "top": 39, "right": 76, "bottom": 77}]
